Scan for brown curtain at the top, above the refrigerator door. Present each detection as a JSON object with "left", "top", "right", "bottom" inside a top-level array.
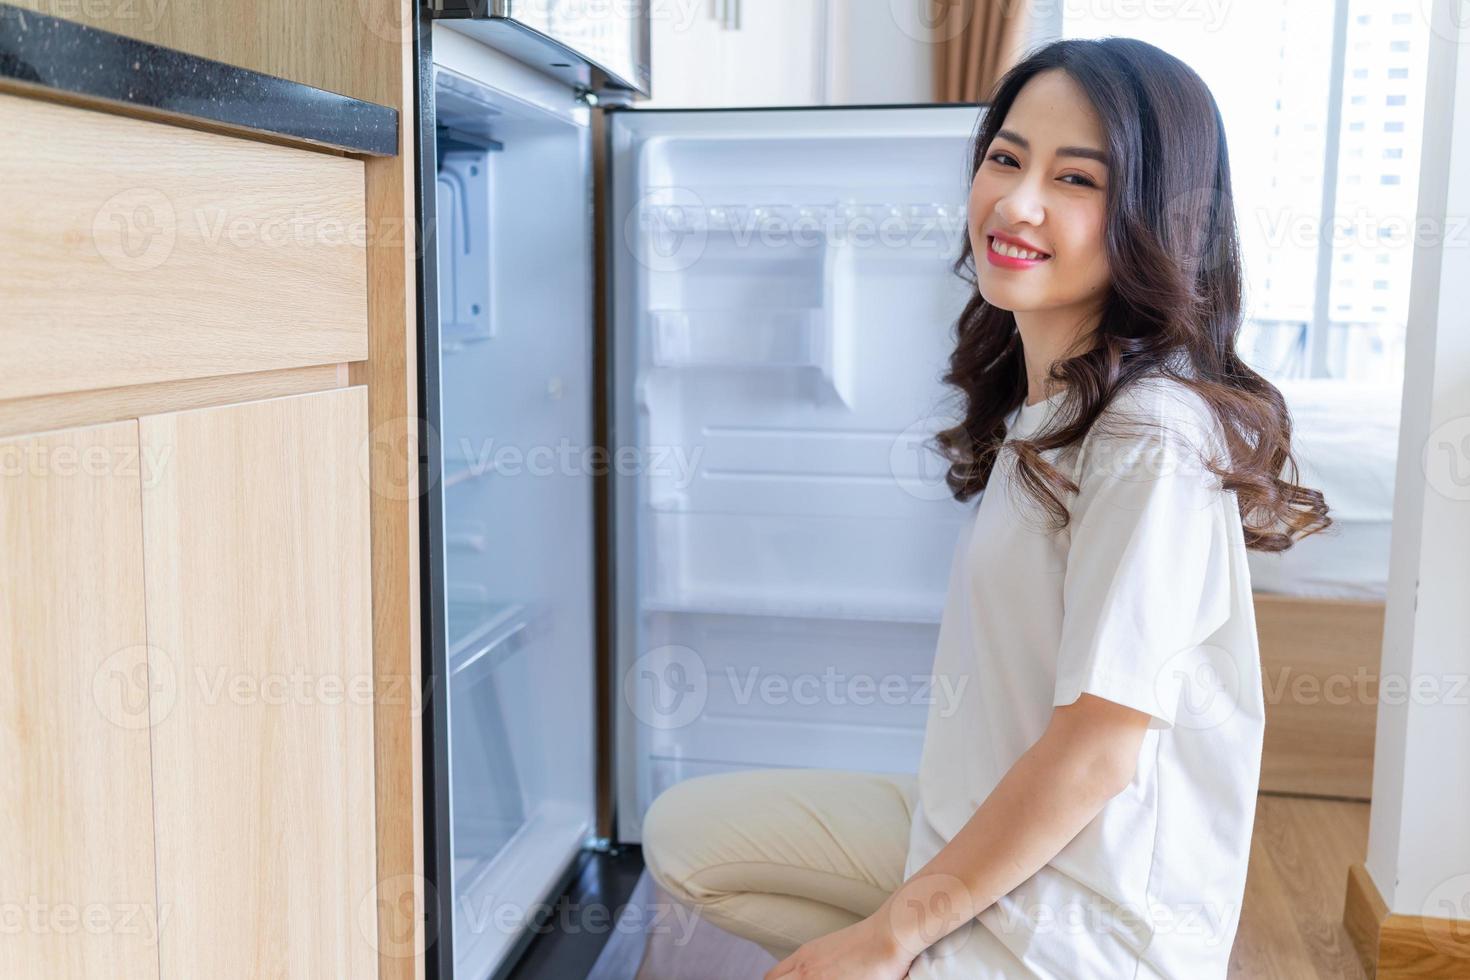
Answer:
[{"left": 916, "top": 0, "right": 1035, "bottom": 101}]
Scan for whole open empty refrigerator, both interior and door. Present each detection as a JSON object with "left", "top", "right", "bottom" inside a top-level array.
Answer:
[{"left": 417, "top": 9, "right": 983, "bottom": 980}]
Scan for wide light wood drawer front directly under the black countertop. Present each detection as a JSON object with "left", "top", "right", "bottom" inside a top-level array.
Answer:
[{"left": 0, "top": 94, "right": 368, "bottom": 400}]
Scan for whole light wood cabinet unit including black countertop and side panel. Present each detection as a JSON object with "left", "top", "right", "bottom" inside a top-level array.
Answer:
[{"left": 0, "top": 0, "right": 428, "bottom": 980}]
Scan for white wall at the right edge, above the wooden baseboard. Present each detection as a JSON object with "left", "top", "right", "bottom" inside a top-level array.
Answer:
[{"left": 1367, "top": 0, "right": 1470, "bottom": 918}]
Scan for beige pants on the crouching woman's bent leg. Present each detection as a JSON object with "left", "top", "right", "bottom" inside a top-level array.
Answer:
[{"left": 642, "top": 768, "right": 917, "bottom": 959}]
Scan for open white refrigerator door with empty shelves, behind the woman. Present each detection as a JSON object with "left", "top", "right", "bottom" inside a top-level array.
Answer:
[{"left": 604, "top": 104, "right": 983, "bottom": 840}]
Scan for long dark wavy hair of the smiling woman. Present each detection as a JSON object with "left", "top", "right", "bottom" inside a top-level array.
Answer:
[{"left": 935, "top": 37, "right": 1332, "bottom": 551}]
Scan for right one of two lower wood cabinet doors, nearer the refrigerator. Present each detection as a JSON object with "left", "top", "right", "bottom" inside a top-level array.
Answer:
[{"left": 140, "top": 386, "right": 378, "bottom": 980}]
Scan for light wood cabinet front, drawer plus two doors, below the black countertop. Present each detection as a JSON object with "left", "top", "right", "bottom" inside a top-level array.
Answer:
[{"left": 0, "top": 42, "right": 402, "bottom": 980}]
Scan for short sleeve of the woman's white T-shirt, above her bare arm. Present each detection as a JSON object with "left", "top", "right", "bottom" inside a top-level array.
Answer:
[{"left": 1053, "top": 402, "right": 1233, "bottom": 729}]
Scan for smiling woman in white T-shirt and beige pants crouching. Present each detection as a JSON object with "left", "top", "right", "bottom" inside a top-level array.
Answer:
[{"left": 644, "top": 38, "right": 1330, "bottom": 980}]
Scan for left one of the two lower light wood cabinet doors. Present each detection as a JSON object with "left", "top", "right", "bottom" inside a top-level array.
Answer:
[{"left": 0, "top": 422, "right": 159, "bottom": 980}]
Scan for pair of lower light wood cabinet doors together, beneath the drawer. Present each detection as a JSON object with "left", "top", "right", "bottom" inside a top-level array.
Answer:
[{"left": 0, "top": 386, "right": 378, "bottom": 980}]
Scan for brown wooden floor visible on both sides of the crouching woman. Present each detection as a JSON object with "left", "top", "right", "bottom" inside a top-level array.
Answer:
[{"left": 620, "top": 795, "right": 1369, "bottom": 980}]
